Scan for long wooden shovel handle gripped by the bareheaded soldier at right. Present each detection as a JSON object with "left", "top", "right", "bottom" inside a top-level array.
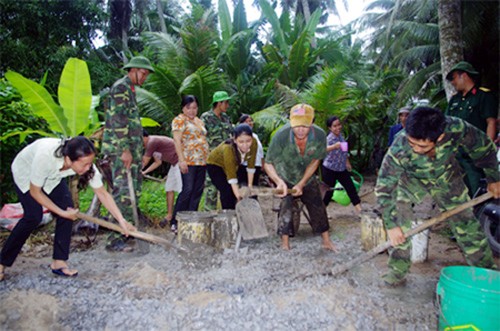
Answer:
[{"left": 331, "top": 192, "right": 493, "bottom": 276}]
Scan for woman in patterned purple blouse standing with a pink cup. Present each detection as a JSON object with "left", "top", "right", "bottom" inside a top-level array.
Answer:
[{"left": 321, "top": 116, "right": 361, "bottom": 213}]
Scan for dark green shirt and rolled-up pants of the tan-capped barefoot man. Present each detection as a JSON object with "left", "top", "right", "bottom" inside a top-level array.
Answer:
[{"left": 266, "top": 124, "right": 330, "bottom": 237}]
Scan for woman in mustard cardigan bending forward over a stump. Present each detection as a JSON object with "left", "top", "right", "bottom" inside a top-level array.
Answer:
[{"left": 207, "top": 124, "right": 258, "bottom": 209}]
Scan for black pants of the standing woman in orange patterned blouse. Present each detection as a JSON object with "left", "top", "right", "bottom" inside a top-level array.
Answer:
[{"left": 171, "top": 166, "right": 207, "bottom": 225}]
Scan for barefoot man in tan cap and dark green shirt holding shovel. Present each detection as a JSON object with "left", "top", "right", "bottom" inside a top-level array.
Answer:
[{"left": 264, "top": 104, "right": 336, "bottom": 250}]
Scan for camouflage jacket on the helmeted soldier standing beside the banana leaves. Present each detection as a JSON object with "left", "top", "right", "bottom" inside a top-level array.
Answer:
[{"left": 102, "top": 76, "right": 144, "bottom": 160}]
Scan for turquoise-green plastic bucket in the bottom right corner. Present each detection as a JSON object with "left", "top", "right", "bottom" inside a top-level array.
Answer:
[{"left": 436, "top": 266, "right": 500, "bottom": 331}]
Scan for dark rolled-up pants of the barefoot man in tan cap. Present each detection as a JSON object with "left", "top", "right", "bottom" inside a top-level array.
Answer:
[{"left": 278, "top": 179, "right": 330, "bottom": 237}]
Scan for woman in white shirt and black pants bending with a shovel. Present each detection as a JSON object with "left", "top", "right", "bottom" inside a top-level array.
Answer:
[{"left": 0, "top": 136, "right": 136, "bottom": 281}]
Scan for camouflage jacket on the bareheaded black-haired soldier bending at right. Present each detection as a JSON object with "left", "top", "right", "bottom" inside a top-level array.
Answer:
[{"left": 375, "top": 117, "right": 500, "bottom": 229}]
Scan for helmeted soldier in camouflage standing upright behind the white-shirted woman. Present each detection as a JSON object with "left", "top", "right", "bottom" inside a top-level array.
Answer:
[{"left": 102, "top": 56, "right": 154, "bottom": 251}]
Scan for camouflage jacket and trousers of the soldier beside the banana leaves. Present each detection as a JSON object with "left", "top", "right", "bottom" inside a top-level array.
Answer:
[{"left": 102, "top": 76, "right": 144, "bottom": 239}]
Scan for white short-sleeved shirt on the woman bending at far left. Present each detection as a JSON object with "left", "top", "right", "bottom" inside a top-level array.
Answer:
[{"left": 11, "top": 138, "right": 103, "bottom": 194}]
